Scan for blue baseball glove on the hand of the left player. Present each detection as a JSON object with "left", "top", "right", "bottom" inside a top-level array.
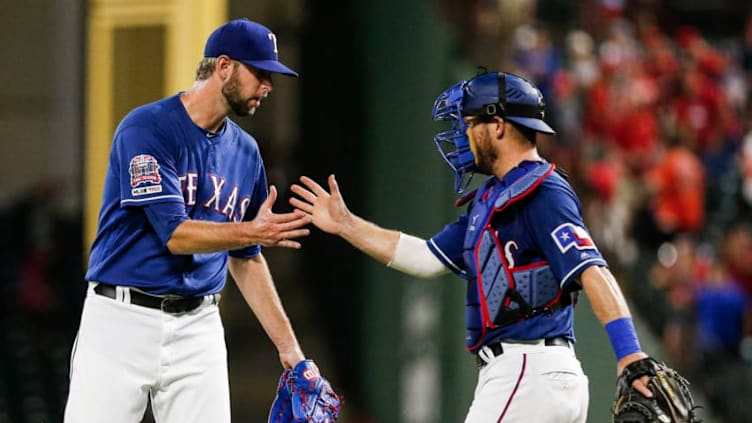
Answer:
[{"left": 269, "top": 360, "right": 342, "bottom": 423}]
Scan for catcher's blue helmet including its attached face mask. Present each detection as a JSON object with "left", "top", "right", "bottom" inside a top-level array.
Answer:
[{"left": 433, "top": 72, "right": 555, "bottom": 193}]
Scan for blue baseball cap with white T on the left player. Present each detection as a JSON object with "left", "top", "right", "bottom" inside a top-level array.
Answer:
[{"left": 204, "top": 18, "right": 298, "bottom": 77}]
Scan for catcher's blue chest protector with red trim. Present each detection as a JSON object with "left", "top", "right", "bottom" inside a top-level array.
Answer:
[{"left": 463, "top": 163, "right": 562, "bottom": 351}]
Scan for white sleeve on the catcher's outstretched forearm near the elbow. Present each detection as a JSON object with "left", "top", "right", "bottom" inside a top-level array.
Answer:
[{"left": 387, "top": 232, "right": 449, "bottom": 279}]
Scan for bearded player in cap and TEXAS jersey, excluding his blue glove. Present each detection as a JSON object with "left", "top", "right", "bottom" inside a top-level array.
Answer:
[{"left": 65, "top": 19, "right": 336, "bottom": 423}]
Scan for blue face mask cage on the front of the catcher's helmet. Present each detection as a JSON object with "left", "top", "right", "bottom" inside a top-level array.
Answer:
[{"left": 432, "top": 81, "right": 477, "bottom": 194}]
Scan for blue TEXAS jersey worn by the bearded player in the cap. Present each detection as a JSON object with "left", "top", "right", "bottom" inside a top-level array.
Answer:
[{"left": 86, "top": 95, "right": 267, "bottom": 296}]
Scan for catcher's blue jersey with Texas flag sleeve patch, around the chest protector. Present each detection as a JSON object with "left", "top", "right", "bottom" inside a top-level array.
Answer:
[{"left": 428, "top": 162, "right": 606, "bottom": 345}]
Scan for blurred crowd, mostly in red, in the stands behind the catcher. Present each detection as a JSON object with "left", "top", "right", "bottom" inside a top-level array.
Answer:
[{"left": 510, "top": 2, "right": 752, "bottom": 421}]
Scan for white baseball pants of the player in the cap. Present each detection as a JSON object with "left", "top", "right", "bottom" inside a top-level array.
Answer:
[{"left": 64, "top": 284, "right": 230, "bottom": 423}]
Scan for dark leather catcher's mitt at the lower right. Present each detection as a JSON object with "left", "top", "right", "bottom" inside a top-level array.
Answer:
[{"left": 611, "top": 357, "right": 700, "bottom": 423}]
